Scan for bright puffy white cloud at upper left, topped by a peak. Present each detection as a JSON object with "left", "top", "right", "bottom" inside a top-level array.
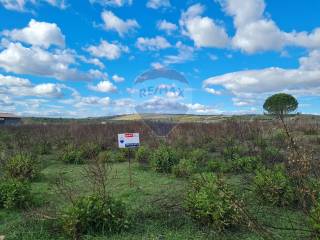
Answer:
[{"left": 2, "top": 19, "right": 65, "bottom": 48}]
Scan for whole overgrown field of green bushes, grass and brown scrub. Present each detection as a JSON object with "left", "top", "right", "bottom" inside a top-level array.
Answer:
[{"left": 0, "top": 106, "right": 320, "bottom": 240}]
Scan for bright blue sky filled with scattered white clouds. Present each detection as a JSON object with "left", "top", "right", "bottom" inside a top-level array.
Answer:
[{"left": 0, "top": 0, "right": 320, "bottom": 118}]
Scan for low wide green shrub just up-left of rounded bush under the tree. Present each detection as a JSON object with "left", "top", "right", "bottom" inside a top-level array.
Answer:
[{"left": 232, "top": 157, "right": 261, "bottom": 173}]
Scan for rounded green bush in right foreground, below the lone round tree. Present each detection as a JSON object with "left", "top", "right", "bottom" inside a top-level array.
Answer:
[{"left": 253, "top": 165, "right": 296, "bottom": 206}]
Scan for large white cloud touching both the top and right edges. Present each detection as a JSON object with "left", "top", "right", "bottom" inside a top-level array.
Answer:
[{"left": 219, "top": 0, "right": 320, "bottom": 54}]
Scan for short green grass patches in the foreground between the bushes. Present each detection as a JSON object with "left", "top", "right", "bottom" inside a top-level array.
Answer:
[{"left": 0, "top": 155, "right": 316, "bottom": 240}]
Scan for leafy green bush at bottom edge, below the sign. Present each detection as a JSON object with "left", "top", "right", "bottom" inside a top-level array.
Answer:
[{"left": 61, "top": 195, "right": 129, "bottom": 239}]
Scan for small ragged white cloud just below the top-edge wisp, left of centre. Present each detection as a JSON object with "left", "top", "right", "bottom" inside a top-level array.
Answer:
[{"left": 101, "top": 11, "right": 139, "bottom": 37}]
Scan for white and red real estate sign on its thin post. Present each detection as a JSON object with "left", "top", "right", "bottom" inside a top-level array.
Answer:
[{"left": 118, "top": 133, "right": 140, "bottom": 187}]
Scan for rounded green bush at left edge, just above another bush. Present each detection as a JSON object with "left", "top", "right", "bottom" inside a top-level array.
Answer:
[{"left": 4, "top": 154, "right": 40, "bottom": 180}]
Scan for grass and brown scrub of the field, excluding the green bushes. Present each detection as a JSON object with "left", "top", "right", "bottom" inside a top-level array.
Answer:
[{"left": 0, "top": 116, "right": 320, "bottom": 240}]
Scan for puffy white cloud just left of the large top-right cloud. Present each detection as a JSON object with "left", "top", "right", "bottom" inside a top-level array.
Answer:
[{"left": 179, "top": 4, "right": 229, "bottom": 48}]
